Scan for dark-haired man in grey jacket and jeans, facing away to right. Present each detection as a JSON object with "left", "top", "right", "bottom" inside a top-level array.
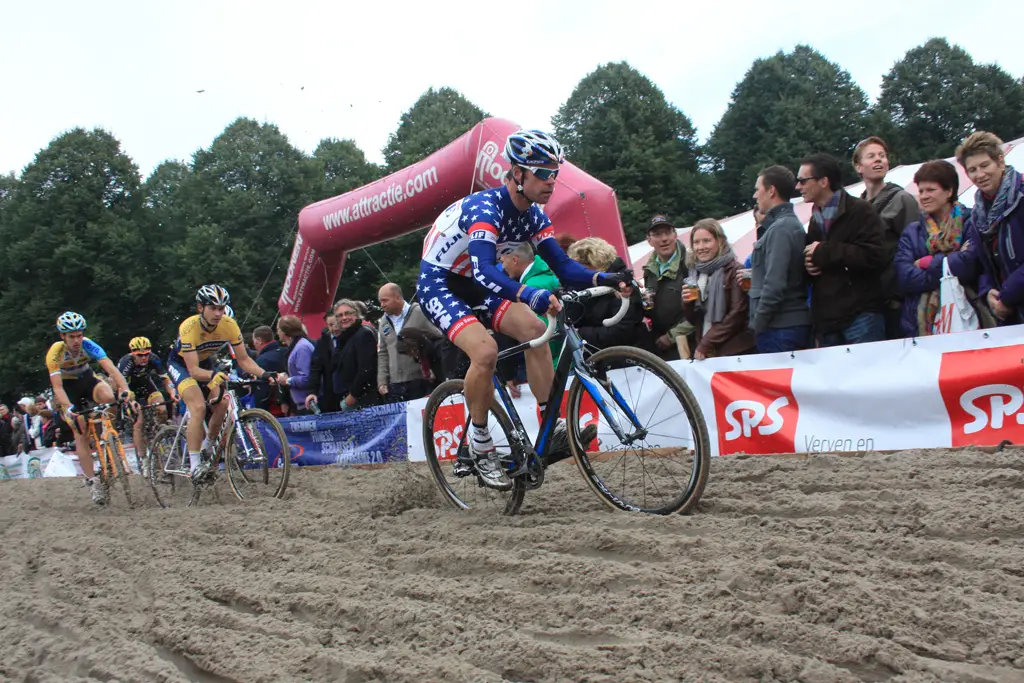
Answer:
[{"left": 750, "top": 166, "right": 811, "bottom": 353}]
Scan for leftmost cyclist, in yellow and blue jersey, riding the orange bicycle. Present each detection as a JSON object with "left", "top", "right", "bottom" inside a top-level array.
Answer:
[{"left": 46, "top": 310, "right": 129, "bottom": 505}]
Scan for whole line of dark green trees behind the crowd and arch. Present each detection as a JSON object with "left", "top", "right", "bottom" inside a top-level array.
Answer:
[{"left": 0, "top": 38, "right": 1024, "bottom": 398}]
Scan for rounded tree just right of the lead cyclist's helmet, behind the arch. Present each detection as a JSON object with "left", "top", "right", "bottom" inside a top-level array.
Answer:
[{"left": 552, "top": 61, "right": 715, "bottom": 241}]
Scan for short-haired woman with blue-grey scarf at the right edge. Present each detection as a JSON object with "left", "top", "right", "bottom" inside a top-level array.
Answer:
[{"left": 956, "top": 131, "right": 1024, "bottom": 325}]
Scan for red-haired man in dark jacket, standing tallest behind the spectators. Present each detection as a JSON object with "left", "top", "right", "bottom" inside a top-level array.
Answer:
[{"left": 853, "top": 135, "right": 921, "bottom": 339}]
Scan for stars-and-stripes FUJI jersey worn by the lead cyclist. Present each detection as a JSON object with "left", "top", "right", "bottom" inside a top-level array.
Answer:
[{"left": 420, "top": 185, "right": 594, "bottom": 301}]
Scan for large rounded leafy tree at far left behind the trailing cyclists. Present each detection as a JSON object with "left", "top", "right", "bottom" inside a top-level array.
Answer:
[{"left": 0, "top": 128, "right": 159, "bottom": 392}]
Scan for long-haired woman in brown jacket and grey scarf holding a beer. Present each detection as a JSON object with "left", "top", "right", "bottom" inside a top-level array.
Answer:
[{"left": 683, "top": 218, "right": 755, "bottom": 360}]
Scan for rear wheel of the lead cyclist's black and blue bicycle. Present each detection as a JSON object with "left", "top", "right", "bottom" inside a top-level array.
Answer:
[{"left": 423, "top": 380, "right": 526, "bottom": 515}]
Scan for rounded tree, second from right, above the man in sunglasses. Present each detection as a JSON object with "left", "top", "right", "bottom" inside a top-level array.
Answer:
[{"left": 706, "top": 45, "right": 868, "bottom": 212}]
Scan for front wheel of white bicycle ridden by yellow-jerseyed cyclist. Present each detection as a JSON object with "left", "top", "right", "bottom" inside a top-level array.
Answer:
[{"left": 224, "top": 408, "right": 292, "bottom": 501}]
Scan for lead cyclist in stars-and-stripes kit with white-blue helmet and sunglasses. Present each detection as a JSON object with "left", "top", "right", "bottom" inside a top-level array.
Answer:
[{"left": 417, "top": 130, "right": 632, "bottom": 488}]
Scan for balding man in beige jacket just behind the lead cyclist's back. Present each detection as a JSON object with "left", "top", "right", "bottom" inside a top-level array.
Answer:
[{"left": 377, "top": 283, "right": 441, "bottom": 402}]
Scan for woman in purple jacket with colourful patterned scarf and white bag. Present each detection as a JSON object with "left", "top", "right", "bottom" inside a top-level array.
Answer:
[{"left": 895, "top": 161, "right": 991, "bottom": 337}]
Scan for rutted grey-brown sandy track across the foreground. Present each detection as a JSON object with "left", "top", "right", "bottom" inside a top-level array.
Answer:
[{"left": 0, "top": 452, "right": 1024, "bottom": 683}]
